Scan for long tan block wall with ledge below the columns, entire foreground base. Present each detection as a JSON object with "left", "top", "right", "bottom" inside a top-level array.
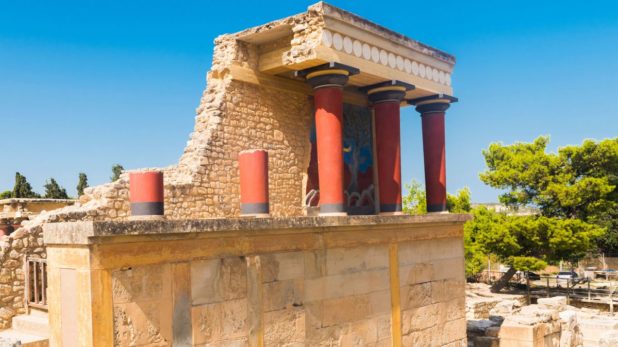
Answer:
[{"left": 45, "top": 214, "right": 469, "bottom": 347}]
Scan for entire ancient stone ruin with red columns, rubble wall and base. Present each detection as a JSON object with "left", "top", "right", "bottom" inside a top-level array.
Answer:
[{"left": 0, "top": 2, "right": 468, "bottom": 346}]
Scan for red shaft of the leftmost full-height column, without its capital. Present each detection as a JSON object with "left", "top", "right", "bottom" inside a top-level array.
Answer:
[{"left": 314, "top": 86, "right": 346, "bottom": 214}]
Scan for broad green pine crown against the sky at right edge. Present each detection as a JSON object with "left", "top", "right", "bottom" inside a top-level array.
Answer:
[{"left": 481, "top": 137, "right": 618, "bottom": 253}]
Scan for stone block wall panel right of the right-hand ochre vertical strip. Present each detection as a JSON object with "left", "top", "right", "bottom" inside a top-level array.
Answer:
[{"left": 399, "top": 239, "right": 466, "bottom": 346}]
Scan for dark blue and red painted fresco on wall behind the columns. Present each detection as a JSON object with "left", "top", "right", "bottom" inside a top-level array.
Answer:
[{"left": 305, "top": 104, "right": 375, "bottom": 214}]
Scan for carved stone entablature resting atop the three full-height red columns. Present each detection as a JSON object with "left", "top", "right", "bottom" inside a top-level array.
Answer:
[{"left": 235, "top": 2, "right": 455, "bottom": 99}]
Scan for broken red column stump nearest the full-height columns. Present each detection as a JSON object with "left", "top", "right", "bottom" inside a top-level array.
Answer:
[{"left": 238, "top": 149, "right": 269, "bottom": 217}]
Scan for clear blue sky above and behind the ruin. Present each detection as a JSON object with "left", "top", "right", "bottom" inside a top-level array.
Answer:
[{"left": 0, "top": 0, "right": 618, "bottom": 202}]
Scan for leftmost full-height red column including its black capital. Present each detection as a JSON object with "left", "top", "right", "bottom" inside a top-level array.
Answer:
[{"left": 299, "top": 63, "right": 358, "bottom": 215}]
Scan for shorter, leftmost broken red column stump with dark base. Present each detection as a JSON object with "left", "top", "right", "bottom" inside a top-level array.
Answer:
[{"left": 129, "top": 171, "right": 164, "bottom": 219}]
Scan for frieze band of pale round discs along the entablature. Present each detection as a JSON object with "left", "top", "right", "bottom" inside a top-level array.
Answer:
[{"left": 322, "top": 30, "right": 451, "bottom": 86}]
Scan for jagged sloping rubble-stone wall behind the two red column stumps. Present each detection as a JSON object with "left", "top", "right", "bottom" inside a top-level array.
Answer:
[{"left": 74, "top": 11, "right": 321, "bottom": 220}]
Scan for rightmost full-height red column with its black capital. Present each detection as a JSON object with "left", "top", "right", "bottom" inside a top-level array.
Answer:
[{"left": 411, "top": 95, "right": 457, "bottom": 213}]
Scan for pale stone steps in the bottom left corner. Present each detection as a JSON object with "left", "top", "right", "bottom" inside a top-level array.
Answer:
[{"left": 0, "top": 309, "right": 49, "bottom": 347}]
